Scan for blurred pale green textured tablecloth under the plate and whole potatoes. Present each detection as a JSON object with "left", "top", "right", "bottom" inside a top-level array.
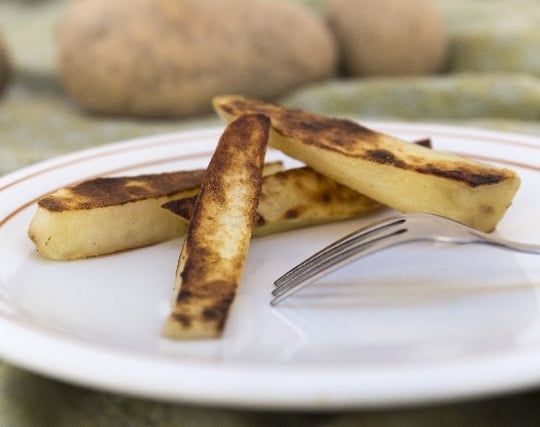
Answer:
[{"left": 0, "top": 0, "right": 540, "bottom": 427}]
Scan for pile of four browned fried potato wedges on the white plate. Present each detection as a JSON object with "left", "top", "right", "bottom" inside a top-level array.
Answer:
[{"left": 28, "top": 96, "right": 520, "bottom": 339}]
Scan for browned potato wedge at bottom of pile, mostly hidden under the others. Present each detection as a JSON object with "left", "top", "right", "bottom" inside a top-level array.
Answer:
[{"left": 163, "top": 166, "right": 384, "bottom": 236}]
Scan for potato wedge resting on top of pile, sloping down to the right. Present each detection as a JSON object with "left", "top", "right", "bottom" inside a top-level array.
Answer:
[{"left": 213, "top": 96, "right": 520, "bottom": 232}]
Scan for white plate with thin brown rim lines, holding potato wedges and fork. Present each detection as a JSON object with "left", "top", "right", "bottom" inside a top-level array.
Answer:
[{"left": 0, "top": 123, "right": 540, "bottom": 409}]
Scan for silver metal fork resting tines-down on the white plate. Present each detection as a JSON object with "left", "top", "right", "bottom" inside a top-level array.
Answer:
[{"left": 270, "top": 213, "right": 540, "bottom": 305}]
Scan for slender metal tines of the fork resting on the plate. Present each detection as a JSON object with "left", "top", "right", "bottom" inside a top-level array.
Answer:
[{"left": 271, "top": 217, "right": 406, "bottom": 305}]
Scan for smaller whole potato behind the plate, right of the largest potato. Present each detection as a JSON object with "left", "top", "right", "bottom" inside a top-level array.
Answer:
[{"left": 326, "top": 0, "right": 448, "bottom": 76}]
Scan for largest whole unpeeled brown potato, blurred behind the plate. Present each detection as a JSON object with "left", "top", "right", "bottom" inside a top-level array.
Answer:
[{"left": 58, "top": 0, "right": 337, "bottom": 117}]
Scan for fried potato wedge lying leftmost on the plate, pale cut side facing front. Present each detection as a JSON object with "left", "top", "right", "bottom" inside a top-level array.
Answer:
[{"left": 28, "top": 161, "right": 283, "bottom": 260}]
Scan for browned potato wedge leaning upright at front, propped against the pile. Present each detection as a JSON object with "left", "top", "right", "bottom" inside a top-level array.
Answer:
[{"left": 162, "top": 114, "right": 270, "bottom": 339}]
